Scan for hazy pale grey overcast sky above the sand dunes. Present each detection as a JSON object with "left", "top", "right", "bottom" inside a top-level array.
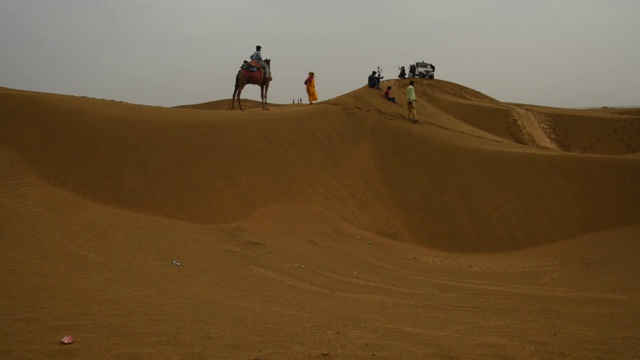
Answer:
[{"left": 0, "top": 0, "right": 640, "bottom": 107}]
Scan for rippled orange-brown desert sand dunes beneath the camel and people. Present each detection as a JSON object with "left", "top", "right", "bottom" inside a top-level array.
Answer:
[{"left": 0, "top": 79, "right": 640, "bottom": 360}]
